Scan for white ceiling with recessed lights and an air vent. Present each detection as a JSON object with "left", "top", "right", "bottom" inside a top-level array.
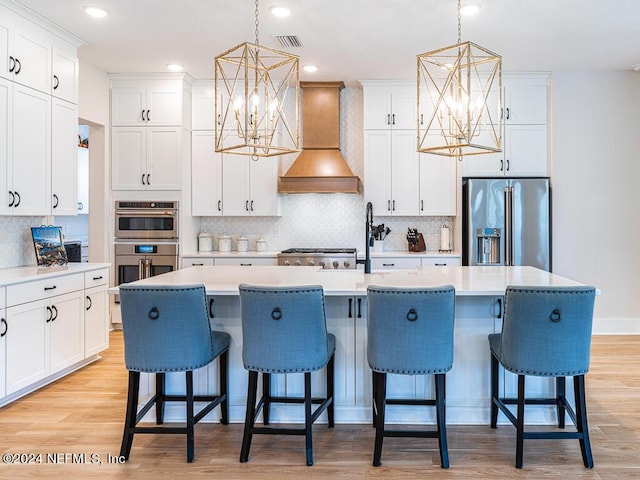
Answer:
[{"left": 10, "top": 0, "right": 640, "bottom": 84}]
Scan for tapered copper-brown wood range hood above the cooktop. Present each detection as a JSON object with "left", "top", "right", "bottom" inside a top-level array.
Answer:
[{"left": 278, "top": 82, "right": 360, "bottom": 193}]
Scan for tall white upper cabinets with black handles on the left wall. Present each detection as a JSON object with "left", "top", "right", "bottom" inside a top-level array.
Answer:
[{"left": 0, "top": 4, "right": 78, "bottom": 216}]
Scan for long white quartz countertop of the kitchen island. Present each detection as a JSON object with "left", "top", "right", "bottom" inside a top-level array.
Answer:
[{"left": 109, "top": 266, "right": 583, "bottom": 296}]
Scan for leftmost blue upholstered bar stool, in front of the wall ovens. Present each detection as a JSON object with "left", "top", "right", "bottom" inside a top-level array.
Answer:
[{"left": 120, "top": 285, "right": 230, "bottom": 462}]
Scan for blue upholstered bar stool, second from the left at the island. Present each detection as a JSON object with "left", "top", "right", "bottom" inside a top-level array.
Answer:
[{"left": 239, "top": 285, "right": 336, "bottom": 465}]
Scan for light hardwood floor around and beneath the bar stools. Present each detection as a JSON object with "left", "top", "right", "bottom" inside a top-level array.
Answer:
[{"left": 0, "top": 332, "right": 640, "bottom": 480}]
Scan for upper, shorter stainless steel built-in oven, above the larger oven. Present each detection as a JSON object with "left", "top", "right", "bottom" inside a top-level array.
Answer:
[{"left": 115, "top": 201, "right": 178, "bottom": 241}]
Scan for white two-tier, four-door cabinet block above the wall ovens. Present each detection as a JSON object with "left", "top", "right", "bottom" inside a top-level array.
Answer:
[{"left": 111, "top": 74, "right": 191, "bottom": 190}]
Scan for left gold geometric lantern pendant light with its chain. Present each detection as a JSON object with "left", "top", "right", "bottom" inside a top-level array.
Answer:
[{"left": 215, "top": 0, "right": 300, "bottom": 160}]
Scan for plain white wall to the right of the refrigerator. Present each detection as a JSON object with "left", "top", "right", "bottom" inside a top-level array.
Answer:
[{"left": 552, "top": 71, "right": 640, "bottom": 333}]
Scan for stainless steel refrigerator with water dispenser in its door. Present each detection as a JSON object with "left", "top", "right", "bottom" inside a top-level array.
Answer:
[{"left": 462, "top": 178, "right": 551, "bottom": 271}]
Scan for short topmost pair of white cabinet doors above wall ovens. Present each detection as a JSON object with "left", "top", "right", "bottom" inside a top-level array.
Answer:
[{"left": 111, "top": 79, "right": 184, "bottom": 127}]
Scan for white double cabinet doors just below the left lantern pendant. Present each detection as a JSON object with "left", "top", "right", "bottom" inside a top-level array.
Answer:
[{"left": 222, "top": 155, "right": 279, "bottom": 216}]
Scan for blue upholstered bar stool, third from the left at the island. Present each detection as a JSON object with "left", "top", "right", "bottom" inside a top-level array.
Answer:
[{"left": 367, "top": 285, "right": 455, "bottom": 468}]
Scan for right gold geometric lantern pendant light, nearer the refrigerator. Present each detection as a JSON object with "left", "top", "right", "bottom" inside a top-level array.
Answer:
[{"left": 417, "top": 0, "right": 502, "bottom": 157}]
